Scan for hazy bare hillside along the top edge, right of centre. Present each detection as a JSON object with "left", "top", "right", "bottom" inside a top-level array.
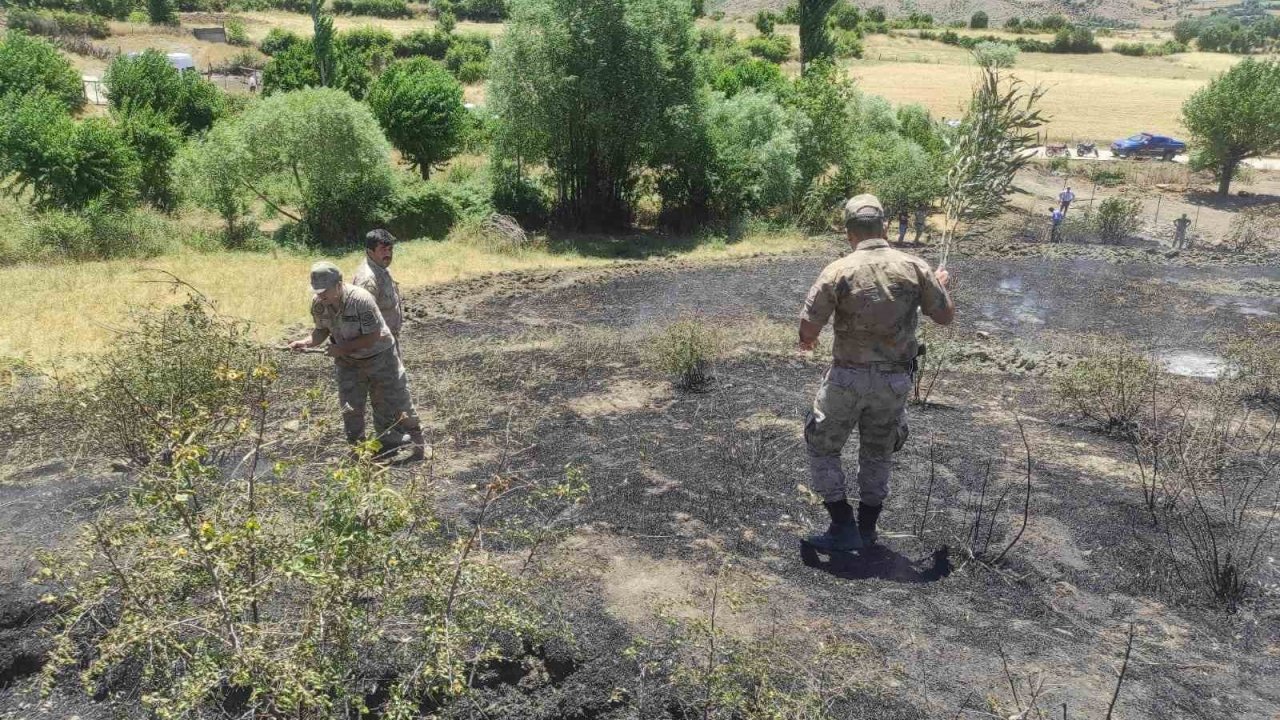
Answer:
[{"left": 708, "top": 0, "right": 1236, "bottom": 27}]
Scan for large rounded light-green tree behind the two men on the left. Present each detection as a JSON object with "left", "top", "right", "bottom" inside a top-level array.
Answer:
[{"left": 183, "top": 88, "right": 392, "bottom": 245}]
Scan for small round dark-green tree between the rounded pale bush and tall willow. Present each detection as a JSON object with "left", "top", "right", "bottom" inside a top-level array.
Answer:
[{"left": 367, "top": 58, "right": 467, "bottom": 179}]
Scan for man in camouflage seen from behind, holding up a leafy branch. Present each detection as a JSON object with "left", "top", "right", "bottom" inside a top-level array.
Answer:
[{"left": 800, "top": 195, "right": 955, "bottom": 551}]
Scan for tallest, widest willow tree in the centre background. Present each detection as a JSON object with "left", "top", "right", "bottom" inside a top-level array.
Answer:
[{"left": 489, "top": 0, "right": 698, "bottom": 229}]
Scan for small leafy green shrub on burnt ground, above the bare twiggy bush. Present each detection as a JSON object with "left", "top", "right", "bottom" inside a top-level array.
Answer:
[{"left": 1053, "top": 347, "right": 1160, "bottom": 437}]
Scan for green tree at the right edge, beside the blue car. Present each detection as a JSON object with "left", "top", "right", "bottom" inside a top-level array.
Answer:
[{"left": 1183, "top": 58, "right": 1280, "bottom": 195}]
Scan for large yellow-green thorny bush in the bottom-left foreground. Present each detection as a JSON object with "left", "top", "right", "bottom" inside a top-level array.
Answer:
[{"left": 38, "top": 376, "right": 586, "bottom": 719}]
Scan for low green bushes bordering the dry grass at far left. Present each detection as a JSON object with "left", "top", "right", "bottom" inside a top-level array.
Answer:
[{"left": 24, "top": 204, "right": 170, "bottom": 263}]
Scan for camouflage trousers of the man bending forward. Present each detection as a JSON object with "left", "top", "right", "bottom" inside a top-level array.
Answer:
[{"left": 334, "top": 347, "right": 419, "bottom": 443}]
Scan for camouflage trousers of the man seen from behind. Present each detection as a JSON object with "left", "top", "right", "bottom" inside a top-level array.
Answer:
[{"left": 804, "top": 368, "right": 911, "bottom": 505}]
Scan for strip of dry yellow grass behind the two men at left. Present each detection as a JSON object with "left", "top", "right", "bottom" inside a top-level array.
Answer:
[{"left": 0, "top": 228, "right": 813, "bottom": 366}]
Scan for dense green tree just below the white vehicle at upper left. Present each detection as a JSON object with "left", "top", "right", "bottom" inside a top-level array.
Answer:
[{"left": 102, "top": 50, "right": 224, "bottom": 133}]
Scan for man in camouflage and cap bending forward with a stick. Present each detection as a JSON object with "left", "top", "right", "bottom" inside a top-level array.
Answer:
[{"left": 289, "top": 263, "right": 425, "bottom": 460}]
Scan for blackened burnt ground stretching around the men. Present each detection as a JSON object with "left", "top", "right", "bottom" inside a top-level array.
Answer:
[{"left": 0, "top": 243, "right": 1280, "bottom": 719}]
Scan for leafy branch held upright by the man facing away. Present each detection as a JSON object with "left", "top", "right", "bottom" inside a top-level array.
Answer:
[{"left": 938, "top": 65, "right": 1046, "bottom": 268}]
